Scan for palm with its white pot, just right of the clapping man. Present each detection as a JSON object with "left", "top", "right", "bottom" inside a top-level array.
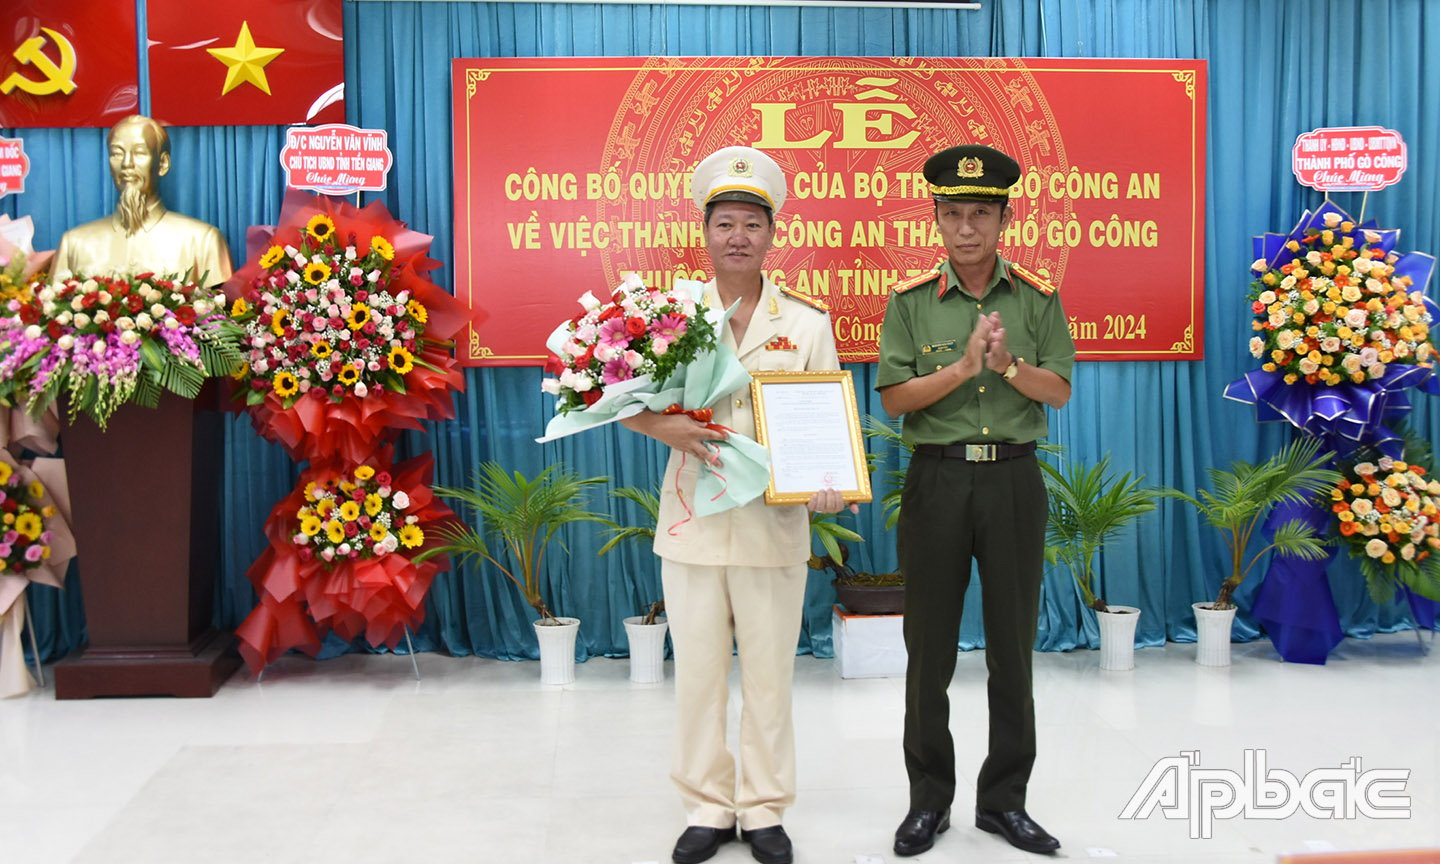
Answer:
[{"left": 1040, "top": 455, "right": 1155, "bottom": 671}]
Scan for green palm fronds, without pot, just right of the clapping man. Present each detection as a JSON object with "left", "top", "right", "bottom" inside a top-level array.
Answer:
[{"left": 1040, "top": 454, "right": 1155, "bottom": 612}]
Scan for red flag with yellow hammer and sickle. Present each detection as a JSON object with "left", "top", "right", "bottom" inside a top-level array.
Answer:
[{"left": 0, "top": 0, "right": 138, "bottom": 128}]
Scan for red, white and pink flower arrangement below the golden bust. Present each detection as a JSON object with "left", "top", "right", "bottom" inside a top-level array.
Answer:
[{"left": 0, "top": 274, "right": 242, "bottom": 429}]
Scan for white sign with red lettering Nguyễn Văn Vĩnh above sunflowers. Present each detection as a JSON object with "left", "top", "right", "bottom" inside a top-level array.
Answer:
[{"left": 279, "top": 122, "right": 395, "bottom": 194}]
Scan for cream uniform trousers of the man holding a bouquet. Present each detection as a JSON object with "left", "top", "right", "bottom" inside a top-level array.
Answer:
[{"left": 661, "top": 559, "right": 805, "bottom": 831}]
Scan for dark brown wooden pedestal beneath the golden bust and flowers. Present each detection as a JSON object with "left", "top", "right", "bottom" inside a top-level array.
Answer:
[{"left": 55, "top": 382, "right": 240, "bottom": 698}]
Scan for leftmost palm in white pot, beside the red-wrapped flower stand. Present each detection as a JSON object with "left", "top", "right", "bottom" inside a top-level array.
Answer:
[{"left": 416, "top": 462, "right": 609, "bottom": 684}]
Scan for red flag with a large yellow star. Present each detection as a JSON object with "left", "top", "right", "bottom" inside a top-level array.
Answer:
[{"left": 147, "top": 0, "right": 346, "bottom": 125}]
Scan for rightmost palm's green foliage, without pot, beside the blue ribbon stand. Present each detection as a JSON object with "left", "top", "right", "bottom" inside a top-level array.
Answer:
[{"left": 1159, "top": 436, "right": 1341, "bottom": 609}]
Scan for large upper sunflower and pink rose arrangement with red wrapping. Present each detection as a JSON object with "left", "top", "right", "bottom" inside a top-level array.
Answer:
[{"left": 228, "top": 193, "right": 474, "bottom": 464}]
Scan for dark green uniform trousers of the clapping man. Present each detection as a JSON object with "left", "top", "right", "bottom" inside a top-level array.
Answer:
[{"left": 897, "top": 454, "right": 1047, "bottom": 811}]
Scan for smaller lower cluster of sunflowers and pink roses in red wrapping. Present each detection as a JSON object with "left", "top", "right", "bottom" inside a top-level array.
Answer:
[{"left": 294, "top": 465, "right": 425, "bottom": 567}]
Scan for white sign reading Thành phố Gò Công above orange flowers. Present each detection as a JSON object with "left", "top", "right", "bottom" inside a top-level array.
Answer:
[{"left": 1290, "top": 127, "right": 1407, "bottom": 192}]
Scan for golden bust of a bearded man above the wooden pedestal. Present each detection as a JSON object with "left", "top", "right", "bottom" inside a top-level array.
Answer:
[{"left": 50, "top": 114, "right": 230, "bottom": 287}]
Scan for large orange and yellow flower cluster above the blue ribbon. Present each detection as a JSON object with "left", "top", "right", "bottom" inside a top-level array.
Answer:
[{"left": 1250, "top": 210, "right": 1434, "bottom": 384}]
